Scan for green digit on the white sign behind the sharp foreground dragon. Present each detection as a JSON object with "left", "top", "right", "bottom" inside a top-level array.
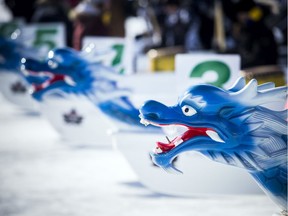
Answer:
[{"left": 190, "top": 61, "right": 231, "bottom": 87}]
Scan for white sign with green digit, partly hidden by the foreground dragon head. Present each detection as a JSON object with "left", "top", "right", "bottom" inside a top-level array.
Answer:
[{"left": 175, "top": 54, "right": 241, "bottom": 92}]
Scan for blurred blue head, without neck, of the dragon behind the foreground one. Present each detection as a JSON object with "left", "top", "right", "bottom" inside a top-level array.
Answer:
[{"left": 21, "top": 47, "right": 122, "bottom": 101}]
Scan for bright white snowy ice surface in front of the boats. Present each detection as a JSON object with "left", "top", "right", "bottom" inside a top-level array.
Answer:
[{"left": 0, "top": 95, "right": 278, "bottom": 216}]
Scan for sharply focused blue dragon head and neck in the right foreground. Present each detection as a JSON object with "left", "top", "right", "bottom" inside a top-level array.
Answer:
[{"left": 140, "top": 78, "right": 287, "bottom": 208}]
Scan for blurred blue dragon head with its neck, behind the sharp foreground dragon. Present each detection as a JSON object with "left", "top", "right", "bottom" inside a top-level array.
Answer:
[{"left": 22, "top": 48, "right": 159, "bottom": 131}]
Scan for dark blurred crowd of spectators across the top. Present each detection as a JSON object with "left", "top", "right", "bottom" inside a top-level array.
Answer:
[{"left": 0, "top": 0, "right": 287, "bottom": 74}]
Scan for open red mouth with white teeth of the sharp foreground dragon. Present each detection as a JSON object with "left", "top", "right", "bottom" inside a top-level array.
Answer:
[{"left": 140, "top": 116, "right": 224, "bottom": 154}]
